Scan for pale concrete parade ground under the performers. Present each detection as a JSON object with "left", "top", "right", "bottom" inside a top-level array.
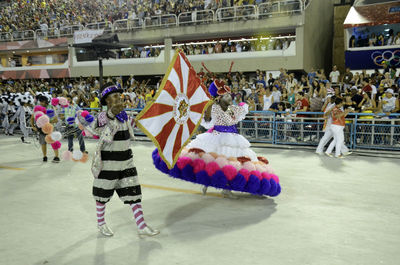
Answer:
[{"left": 0, "top": 136, "right": 400, "bottom": 265}]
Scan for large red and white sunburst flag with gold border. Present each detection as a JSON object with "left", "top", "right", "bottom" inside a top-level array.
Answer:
[{"left": 136, "top": 50, "right": 212, "bottom": 168}]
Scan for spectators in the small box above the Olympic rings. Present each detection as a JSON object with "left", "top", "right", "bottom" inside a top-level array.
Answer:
[{"left": 349, "top": 29, "right": 400, "bottom": 48}]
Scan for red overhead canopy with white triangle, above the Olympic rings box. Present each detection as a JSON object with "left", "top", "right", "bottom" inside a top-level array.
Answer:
[{"left": 344, "top": 2, "right": 400, "bottom": 28}]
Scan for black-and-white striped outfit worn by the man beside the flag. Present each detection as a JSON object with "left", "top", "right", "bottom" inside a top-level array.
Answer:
[{"left": 93, "top": 112, "right": 142, "bottom": 204}]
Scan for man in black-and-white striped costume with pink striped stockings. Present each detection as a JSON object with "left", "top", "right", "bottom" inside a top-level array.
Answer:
[{"left": 86, "top": 84, "right": 159, "bottom": 236}]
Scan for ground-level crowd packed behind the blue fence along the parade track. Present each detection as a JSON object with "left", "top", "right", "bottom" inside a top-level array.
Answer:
[{"left": 0, "top": 63, "right": 400, "bottom": 115}]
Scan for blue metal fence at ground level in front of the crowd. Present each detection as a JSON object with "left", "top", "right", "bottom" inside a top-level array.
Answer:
[{"left": 79, "top": 109, "right": 400, "bottom": 151}]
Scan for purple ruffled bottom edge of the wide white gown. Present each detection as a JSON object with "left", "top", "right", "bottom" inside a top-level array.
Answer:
[{"left": 152, "top": 149, "right": 281, "bottom": 197}]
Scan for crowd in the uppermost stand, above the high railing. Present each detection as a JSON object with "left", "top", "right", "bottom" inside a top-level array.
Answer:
[{"left": 0, "top": 0, "right": 275, "bottom": 33}]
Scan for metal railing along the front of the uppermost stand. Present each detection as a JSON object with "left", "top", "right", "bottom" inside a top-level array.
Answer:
[{"left": 0, "top": 0, "right": 310, "bottom": 41}]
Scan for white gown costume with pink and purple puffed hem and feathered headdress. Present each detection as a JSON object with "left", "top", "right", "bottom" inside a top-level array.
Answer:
[{"left": 152, "top": 81, "right": 281, "bottom": 196}]
